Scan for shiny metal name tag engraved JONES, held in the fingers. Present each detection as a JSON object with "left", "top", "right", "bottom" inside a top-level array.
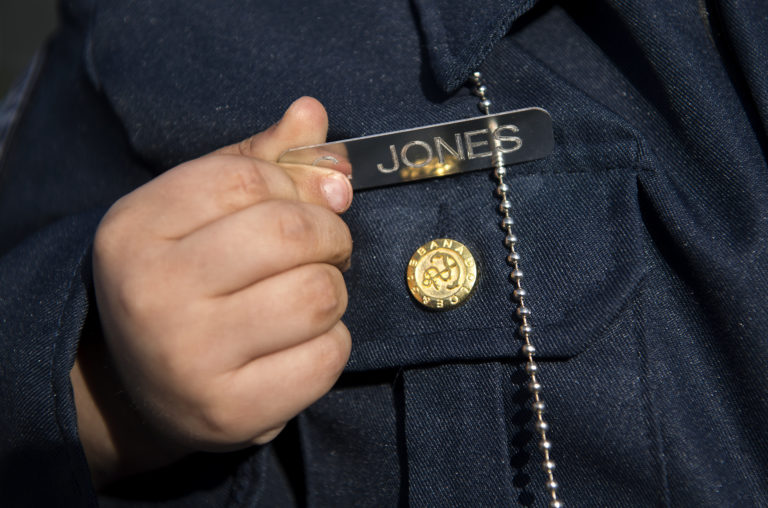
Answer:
[{"left": 278, "top": 108, "right": 554, "bottom": 190}]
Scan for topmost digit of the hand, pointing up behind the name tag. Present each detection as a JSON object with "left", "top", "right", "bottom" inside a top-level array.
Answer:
[{"left": 219, "top": 97, "right": 328, "bottom": 162}]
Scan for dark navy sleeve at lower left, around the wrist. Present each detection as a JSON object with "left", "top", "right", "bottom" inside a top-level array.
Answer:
[{"left": 0, "top": 209, "right": 101, "bottom": 506}]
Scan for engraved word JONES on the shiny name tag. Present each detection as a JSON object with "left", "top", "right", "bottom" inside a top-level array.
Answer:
[{"left": 376, "top": 124, "right": 523, "bottom": 173}]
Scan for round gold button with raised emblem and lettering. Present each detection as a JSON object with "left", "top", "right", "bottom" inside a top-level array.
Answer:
[{"left": 405, "top": 238, "right": 477, "bottom": 310}]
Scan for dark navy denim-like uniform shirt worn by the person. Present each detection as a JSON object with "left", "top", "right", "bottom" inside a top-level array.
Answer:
[{"left": 0, "top": 0, "right": 768, "bottom": 506}]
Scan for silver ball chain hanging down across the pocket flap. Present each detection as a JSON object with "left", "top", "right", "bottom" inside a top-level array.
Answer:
[{"left": 472, "top": 72, "right": 564, "bottom": 508}]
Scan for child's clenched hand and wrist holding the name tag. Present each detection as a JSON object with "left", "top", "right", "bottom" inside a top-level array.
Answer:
[{"left": 72, "top": 98, "right": 352, "bottom": 488}]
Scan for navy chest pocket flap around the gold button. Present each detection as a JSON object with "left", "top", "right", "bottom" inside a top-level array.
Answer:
[{"left": 344, "top": 109, "right": 647, "bottom": 371}]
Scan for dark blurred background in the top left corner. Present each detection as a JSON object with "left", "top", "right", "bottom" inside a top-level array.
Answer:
[{"left": 0, "top": 0, "right": 56, "bottom": 96}]
